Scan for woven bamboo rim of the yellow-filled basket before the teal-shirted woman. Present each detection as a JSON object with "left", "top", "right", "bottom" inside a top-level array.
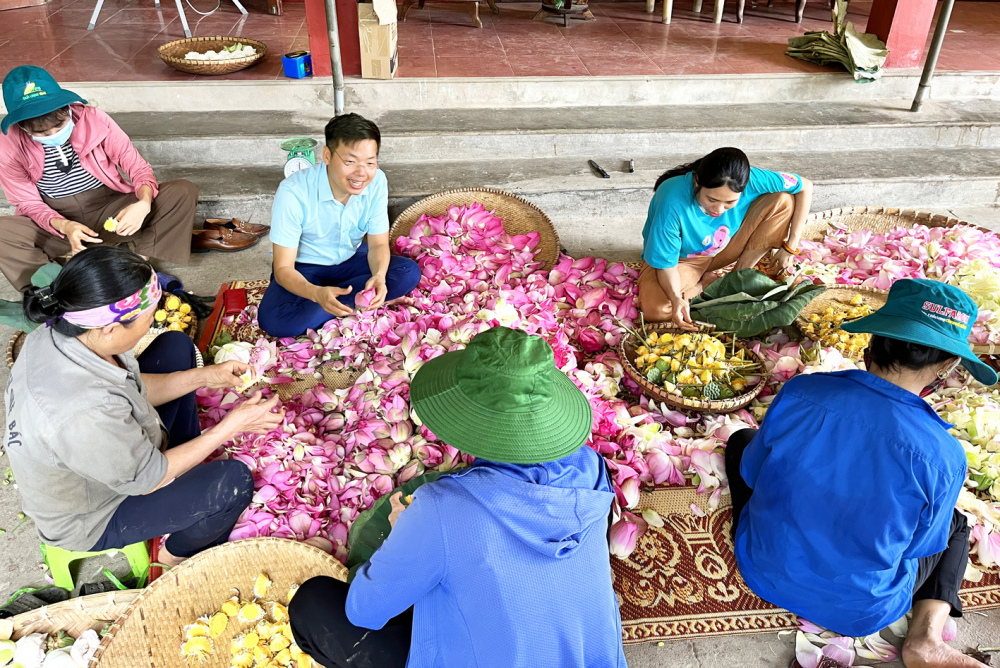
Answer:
[{"left": 619, "top": 322, "right": 771, "bottom": 413}]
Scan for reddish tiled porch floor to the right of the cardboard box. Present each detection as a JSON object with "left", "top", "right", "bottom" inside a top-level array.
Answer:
[{"left": 397, "top": 0, "right": 1000, "bottom": 77}]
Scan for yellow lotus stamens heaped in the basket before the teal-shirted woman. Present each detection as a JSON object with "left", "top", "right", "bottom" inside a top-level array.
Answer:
[{"left": 635, "top": 332, "right": 760, "bottom": 401}]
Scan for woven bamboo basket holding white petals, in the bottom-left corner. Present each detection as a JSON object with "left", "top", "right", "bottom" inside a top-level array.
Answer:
[{"left": 10, "top": 589, "right": 139, "bottom": 640}]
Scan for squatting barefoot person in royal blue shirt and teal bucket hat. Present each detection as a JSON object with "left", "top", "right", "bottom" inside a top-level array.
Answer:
[{"left": 726, "top": 279, "right": 997, "bottom": 668}]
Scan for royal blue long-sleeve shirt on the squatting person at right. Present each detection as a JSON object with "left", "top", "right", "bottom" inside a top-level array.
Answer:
[{"left": 736, "top": 370, "right": 967, "bottom": 636}]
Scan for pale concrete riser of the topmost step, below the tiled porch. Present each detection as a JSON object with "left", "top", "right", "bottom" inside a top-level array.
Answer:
[{"left": 0, "top": 69, "right": 1000, "bottom": 115}]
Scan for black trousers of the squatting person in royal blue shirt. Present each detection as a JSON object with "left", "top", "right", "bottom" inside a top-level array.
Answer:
[{"left": 726, "top": 429, "right": 971, "bottom": 617}]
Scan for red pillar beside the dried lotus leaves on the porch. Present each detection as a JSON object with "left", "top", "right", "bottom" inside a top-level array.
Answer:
[{"left": 866, "top": 0, "right": 937, "bottom": 67}]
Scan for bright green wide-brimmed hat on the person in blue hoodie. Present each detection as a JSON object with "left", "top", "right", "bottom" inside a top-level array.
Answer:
[{"left": 410, "top": 327, "right": 593, "bottom": 464}]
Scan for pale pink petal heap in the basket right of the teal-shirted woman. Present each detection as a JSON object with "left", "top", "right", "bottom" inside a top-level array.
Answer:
[{"left": 795, "top": 225, "right": 1000, "bottom": 290}]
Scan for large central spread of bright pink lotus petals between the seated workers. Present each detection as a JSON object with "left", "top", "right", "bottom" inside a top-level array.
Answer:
[{"left": 191, "top": 204, "right": 988, "bottom": 560}]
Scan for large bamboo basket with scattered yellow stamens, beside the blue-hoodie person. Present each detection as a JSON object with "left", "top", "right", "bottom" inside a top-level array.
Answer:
[{"left": 90, "top": 538, "right": 347, "bottom": 668}]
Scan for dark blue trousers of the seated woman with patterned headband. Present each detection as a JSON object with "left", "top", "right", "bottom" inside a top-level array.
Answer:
[{"left": 91, "top": 332, "right": 253, "bottom": 557}]
